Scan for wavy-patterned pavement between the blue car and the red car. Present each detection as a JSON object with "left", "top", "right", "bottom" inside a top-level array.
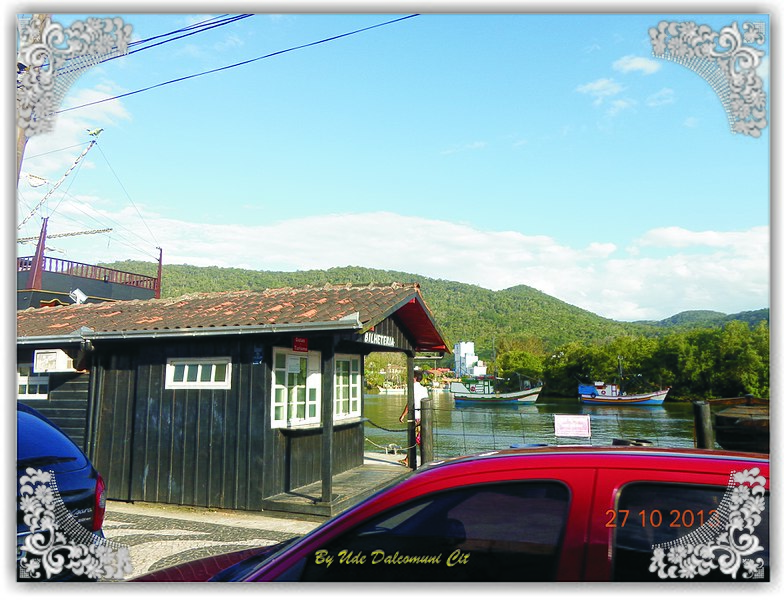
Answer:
[{"left": 103, "top": 501, "right": 325, "bottom": 579}]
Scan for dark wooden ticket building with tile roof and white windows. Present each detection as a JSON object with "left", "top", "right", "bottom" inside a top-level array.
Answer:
[{"left": 17, "top": 284, "right": 448, "bottom": 515}]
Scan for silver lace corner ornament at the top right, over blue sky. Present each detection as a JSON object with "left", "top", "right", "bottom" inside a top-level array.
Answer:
[{"left": 648, "top": 21, "right": 768, "bottom": 137}]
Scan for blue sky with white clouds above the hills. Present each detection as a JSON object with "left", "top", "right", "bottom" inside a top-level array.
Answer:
[{"left": 10, "top": 3, "right": 771, "bottom": 320}]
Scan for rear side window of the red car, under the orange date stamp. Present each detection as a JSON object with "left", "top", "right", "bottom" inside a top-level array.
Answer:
[{"left": 605, "top": 483, "right": 770, "bottom": 581}]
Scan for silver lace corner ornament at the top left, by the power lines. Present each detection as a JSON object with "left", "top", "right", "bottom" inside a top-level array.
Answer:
[{"left": 16, "top": 15, "right": 133, "bottom": 138}]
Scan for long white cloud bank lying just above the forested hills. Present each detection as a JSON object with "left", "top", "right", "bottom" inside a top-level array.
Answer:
[{"left": 43, "top": 212, "right": 769, "bottom": 320}]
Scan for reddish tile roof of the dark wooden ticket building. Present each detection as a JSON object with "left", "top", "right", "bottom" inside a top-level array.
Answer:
[{"left": 16, "top": 283, "right": 448, "bottom": 351}]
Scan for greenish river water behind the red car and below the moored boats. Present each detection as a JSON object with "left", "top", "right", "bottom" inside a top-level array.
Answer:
[{"left": 365, "top": 390, "right": 694, "bottom": 459}]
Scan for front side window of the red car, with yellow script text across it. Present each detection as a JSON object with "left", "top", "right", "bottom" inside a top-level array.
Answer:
[{"left": 290, "top": 481, "right": 569, "bottom": 581}]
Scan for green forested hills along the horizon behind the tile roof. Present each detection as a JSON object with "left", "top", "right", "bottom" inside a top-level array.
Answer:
[{"left": 105, "top": 261, "right": 768, "bottom": 358}]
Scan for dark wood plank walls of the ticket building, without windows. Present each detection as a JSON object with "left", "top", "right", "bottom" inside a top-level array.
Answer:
[{"left": 29, "top": 319, "right": 410, "bottom": 510}]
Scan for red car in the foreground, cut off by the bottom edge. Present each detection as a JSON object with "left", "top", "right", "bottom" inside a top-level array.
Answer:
[{"left": 135, "top": 447, "right": 770, "bottom": 582}]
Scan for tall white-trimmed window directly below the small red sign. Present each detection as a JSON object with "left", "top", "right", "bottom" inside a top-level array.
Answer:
[{"left": 272, "top": 348, "right": 321, "bottom": 427}]
